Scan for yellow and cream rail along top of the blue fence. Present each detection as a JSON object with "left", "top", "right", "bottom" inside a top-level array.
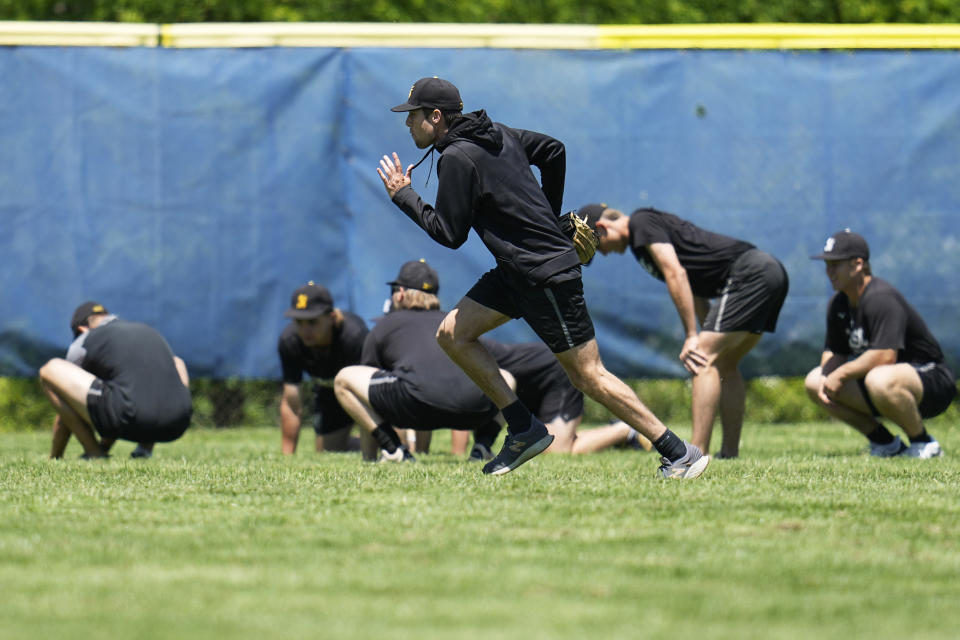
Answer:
[{"left": 0, "top": 21, "right": 960, "bottom": 49}]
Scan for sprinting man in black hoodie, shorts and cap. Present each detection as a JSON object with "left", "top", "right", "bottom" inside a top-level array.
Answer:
[{"left": 377, "top": 78, "right": 710, "bottom": 478}]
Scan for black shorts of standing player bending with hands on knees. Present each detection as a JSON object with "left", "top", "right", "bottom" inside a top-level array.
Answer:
[{"left": 703, "top": 249, "right": 790, "bottom": 333}]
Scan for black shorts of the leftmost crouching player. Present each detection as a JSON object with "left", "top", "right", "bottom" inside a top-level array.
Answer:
[{"left": 87, "top": 378, "right": 192, "bottom": 442}]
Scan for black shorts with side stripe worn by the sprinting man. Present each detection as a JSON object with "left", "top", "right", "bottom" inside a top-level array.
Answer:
[{"left": 467, "top": 267, "right": 594, "bottom": 353}]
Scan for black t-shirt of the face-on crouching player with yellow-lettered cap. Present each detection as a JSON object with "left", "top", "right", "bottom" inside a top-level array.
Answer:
[{"left": 277, "top": 311, "right": 367, "bottom": 384}]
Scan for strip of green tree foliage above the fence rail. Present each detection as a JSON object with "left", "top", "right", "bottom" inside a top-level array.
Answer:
[{"left": 0, "top": 0, "right": 960, "bottom": 24}]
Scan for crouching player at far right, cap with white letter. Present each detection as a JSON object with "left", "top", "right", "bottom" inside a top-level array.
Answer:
[{"left": 806, "top": 229, "right": 957, "bottom": 458}]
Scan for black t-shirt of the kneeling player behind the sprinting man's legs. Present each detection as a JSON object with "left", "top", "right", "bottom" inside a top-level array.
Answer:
[{"left": 480, "top": 338, "right": 573, "bottom": 408}]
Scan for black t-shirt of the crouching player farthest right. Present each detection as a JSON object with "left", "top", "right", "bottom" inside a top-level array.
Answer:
[{"left": 824, "top": 278, "right": 943, "bottom": 364}]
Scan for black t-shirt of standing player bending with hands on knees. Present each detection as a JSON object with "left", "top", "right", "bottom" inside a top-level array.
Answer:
[{"left": 630, "top": 209, "right": 754, "bottom": 298}]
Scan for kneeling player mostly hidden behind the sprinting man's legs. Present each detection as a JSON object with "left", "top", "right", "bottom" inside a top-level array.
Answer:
[{"left": 452, "top": 338, "right": 653, "bottom": 460}]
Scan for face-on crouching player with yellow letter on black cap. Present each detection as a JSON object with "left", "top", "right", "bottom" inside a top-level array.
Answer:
[{"left": 277, "top": 282, "right": 377, "bottom": 458}]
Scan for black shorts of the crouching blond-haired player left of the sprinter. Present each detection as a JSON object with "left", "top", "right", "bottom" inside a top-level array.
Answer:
[{"left": 368, "top": 369, "right": 499, "bottom": 431}]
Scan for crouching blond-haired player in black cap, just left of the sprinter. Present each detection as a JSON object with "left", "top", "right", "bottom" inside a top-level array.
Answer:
[{"left": 334, "top": 260, "right": 499, "bottom": 462}]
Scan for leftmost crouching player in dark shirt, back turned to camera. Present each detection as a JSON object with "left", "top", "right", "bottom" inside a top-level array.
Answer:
[{"left": 40, "top": 302, "right": 193, "bottom": 458}]
